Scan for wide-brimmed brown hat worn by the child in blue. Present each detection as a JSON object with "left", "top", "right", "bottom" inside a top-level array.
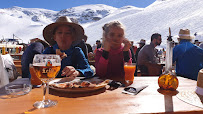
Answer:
[{"left": 43, "top": 16, "right": 84, "bottom": 46}]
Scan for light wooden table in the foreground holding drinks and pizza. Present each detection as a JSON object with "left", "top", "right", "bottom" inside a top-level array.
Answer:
[{"left": 0, "top": 77, "right": 203, "bottom": 114}]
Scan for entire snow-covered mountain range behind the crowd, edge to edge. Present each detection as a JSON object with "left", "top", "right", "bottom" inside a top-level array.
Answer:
[{"left": 0, "top": 0, "right": 203, "bottom": 47}]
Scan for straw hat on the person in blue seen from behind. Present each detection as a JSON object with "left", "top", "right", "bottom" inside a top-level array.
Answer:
[{"left": 178, "top": 29, "right": 194, "bottom": 39}]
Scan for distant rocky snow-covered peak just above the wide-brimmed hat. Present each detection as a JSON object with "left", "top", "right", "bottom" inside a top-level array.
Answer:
[{"left": 56, "top": 4, "right": 117, "bottom": 23}]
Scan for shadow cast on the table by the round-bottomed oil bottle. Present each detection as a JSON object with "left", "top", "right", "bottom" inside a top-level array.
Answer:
[{"left": 157, "top": 88, "right": 179, "bottom": 112}]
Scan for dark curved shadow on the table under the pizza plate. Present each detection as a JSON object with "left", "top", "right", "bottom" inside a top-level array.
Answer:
[{"left": 49, "top": 87, "right": 106, "bottom": 98}]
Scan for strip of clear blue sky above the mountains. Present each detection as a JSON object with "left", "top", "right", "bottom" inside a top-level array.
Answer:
[{"left": 0, "top": 0, "right": 156, "bottom": 11}]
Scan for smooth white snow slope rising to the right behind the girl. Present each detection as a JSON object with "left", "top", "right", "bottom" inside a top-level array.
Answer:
[{"left": 85, "top": 0, "right": 203, "bottom": 47}]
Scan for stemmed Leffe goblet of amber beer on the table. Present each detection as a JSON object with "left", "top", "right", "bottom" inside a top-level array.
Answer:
[{"left": 33, "top": 54, "right": 61, "bottom": 108}]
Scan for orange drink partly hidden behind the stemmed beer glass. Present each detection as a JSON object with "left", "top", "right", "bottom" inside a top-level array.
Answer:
[{"left": 30, "top": 65, "right": 42, "bottom": 85}]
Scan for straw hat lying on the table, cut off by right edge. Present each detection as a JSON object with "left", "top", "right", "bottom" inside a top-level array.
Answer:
[{"left": 177, "top": 69, "right": 203, "bottom": 108}]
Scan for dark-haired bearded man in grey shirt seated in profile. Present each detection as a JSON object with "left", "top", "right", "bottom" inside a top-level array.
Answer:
[{"left": 137, "top": 33, "right": 162, "bottom": 76}]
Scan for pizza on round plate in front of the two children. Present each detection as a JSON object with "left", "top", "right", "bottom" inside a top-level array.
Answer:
[{"left": 49, "top": 77, "right": 109, "bottom": 92}]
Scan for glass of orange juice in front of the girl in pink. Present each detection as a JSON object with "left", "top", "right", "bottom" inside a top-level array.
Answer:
[{"left": 124, "top": 63, "right": 136, "bottom": 82}]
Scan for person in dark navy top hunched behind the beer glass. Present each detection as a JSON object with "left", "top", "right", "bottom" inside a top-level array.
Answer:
[{"left": 21, "top": 38, "right": 49, "bottom": 78}]
